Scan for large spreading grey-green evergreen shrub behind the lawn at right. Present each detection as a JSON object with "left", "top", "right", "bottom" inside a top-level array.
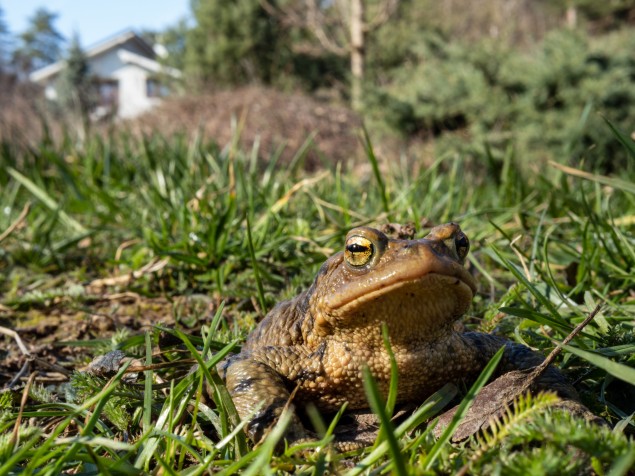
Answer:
[{"left": 371, "top": 30, "right": 635, "bottom": 170}]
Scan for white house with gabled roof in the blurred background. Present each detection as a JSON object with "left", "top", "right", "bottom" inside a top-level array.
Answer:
[{"left": 29, "top": 31, "right": 181, "bottom": 118}]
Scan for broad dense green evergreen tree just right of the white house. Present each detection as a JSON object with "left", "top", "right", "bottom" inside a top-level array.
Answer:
[{"left": 185, "top": 0, "right": 282, "bottom": 84}]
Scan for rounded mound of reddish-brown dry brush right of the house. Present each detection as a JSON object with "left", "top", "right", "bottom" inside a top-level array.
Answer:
[{"left": 126, "top": 86, "right": 361, "bottom": 169}]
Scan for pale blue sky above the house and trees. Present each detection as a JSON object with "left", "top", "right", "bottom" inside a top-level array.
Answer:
[{"left": 0, "top": 0, "right": 190, "bottom": 47}]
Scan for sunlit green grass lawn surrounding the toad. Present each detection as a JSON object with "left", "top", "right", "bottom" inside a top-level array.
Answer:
[{"left": 0, "top": 126, "right": 635, "bottom": 475}]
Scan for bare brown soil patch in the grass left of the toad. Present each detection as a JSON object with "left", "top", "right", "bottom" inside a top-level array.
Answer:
[{"left": 0, "top": 292, "right": 216, "bottom": 388}]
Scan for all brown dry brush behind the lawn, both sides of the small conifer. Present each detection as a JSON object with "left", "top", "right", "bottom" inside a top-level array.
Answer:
[{"left": 0, "top": 81, "right": 362, "bottom": 170}]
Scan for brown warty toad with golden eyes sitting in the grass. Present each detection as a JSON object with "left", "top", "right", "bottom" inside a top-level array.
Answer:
[{"left": 220, "top": 223, "right": 588, "bottom": 443}]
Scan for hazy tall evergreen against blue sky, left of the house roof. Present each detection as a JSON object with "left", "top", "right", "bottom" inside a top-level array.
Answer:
[{"left": 13, "top": 8, "right": 65, "bottom": 75}]
